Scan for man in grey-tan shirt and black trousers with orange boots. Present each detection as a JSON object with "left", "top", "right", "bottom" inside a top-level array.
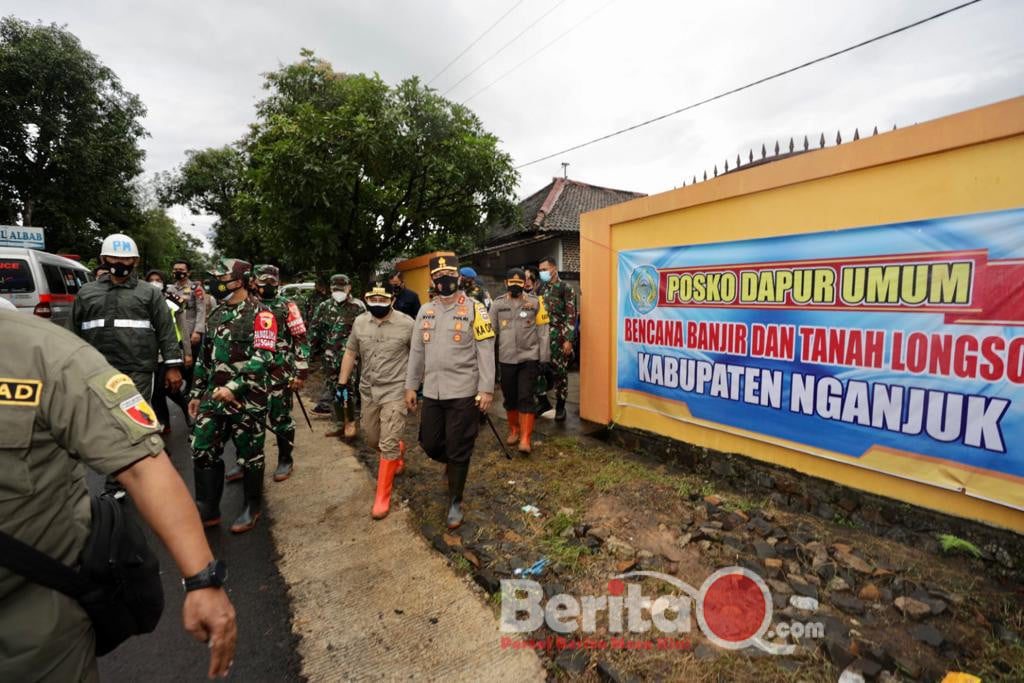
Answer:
[{"left": 490, "top": 268, "right": 551, "bottom": 454}]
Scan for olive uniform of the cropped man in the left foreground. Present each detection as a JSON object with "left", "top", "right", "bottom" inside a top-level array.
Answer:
[{"left": 0, "top": 310, "right": 164, "bottom": 683}]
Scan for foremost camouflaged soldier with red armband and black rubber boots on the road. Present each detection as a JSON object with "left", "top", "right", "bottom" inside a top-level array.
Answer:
[{"left": 188, "top": 258, "right": 278, "bottom": 533}]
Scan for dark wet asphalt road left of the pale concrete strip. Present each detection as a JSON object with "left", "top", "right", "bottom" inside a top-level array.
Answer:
[{"left": 89, "top": 405, "right": 301, "bottom": 683}]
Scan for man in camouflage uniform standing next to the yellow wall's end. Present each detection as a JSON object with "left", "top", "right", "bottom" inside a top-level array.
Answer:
[{"left": 538, "top": 256, "right": 577, "bottom": 421}]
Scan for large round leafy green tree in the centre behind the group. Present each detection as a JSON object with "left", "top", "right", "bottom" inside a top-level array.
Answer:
[{"left": 242, "top": 50, "right": 517, "bottom": 280}]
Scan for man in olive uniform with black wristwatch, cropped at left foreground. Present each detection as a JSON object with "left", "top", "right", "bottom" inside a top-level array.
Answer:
[{"left": 0, "top": 310, "right": 236, "bottom": 683}]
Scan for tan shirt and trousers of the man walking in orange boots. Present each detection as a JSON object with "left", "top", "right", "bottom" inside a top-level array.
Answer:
[{"left": 345, "top": 310, "right": 413, "bottom": 460}]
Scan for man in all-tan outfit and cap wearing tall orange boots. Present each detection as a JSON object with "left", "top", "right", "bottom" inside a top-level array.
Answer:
[{"left": 338, "top": 280, "right": 413, "bottom": 519}]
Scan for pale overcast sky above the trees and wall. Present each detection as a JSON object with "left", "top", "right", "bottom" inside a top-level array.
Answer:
[{"left": 3, "top": 0, "right": 1024, "bottom": 250}]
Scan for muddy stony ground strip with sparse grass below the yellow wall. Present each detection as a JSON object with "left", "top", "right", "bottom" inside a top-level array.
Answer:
[{"left": 337, "top": 403, "right": 1024, "bottom": 681}]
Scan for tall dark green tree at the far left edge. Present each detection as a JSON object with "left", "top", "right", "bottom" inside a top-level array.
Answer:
[{"left": 0, "top": 16, "right": 146, "bottom": 255}]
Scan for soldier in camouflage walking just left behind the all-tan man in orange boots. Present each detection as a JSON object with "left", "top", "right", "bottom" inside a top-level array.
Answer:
[{"left": 310, "top": 274, "right": 366, "bottom": 439}]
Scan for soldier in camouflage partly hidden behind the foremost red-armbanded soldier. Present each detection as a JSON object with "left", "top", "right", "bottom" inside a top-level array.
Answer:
[{"left": 256, "top": 265, "right": 309, "bottom": 481}]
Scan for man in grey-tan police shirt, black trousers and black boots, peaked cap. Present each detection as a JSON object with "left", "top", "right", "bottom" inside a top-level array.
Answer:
[{"left": 406, "top": 256, "right": 495, "bottom": 528}]
